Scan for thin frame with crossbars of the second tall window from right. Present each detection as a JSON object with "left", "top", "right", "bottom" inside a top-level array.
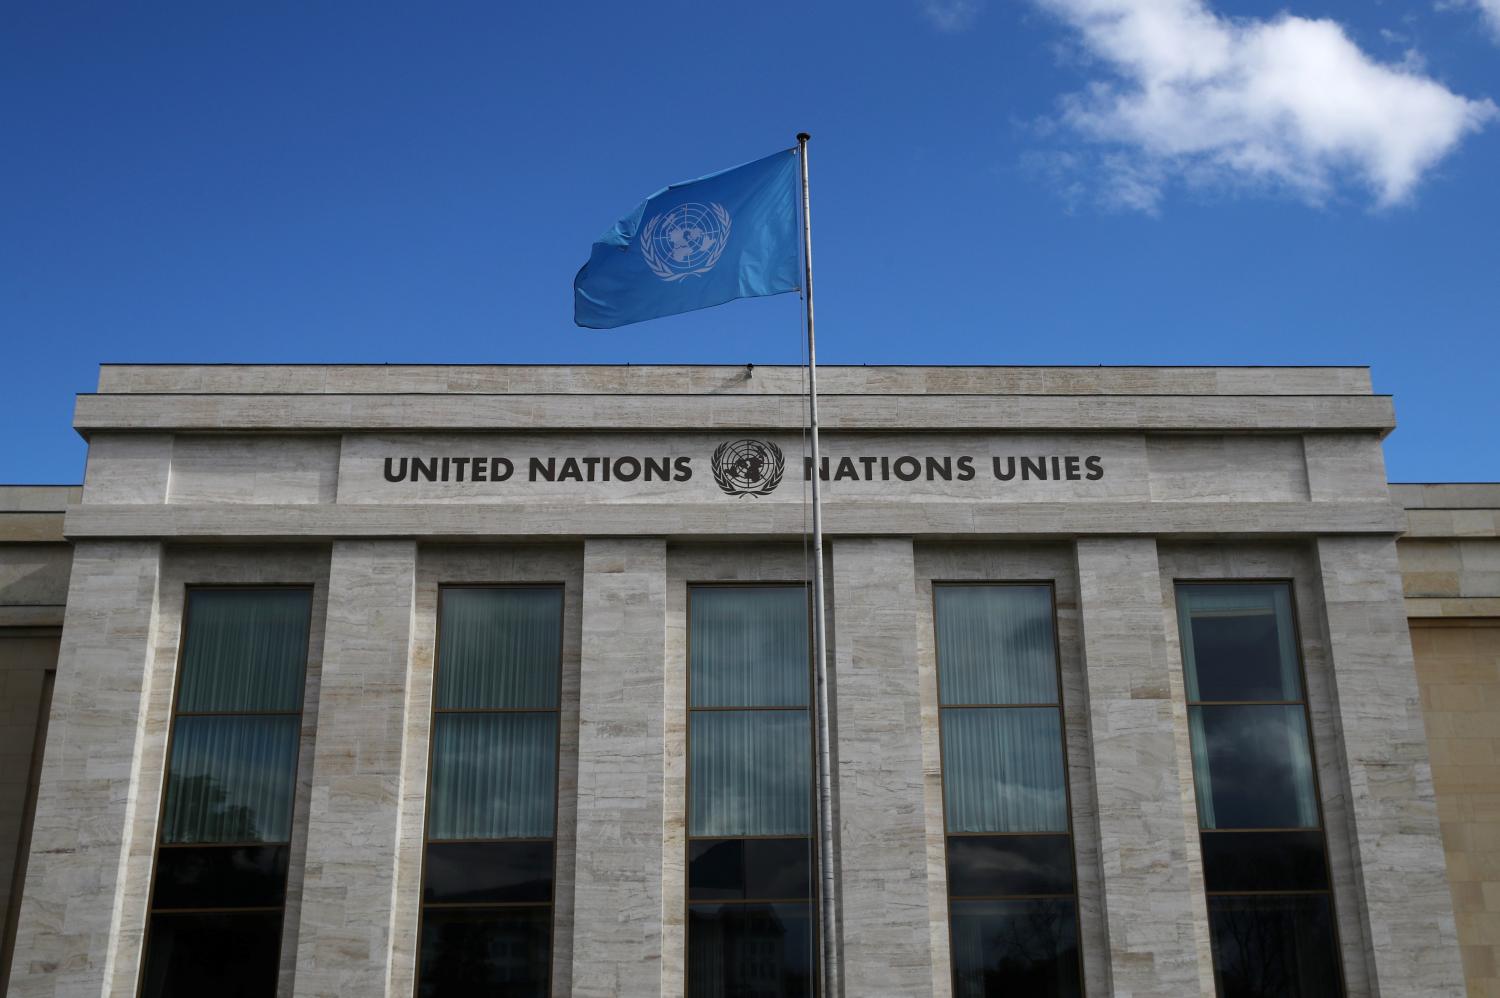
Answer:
[{"left": 929, "top": 578, "right": 1088, "bottom": 995}]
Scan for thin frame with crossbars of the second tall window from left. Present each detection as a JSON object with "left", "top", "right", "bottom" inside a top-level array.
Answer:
[{"left": 411, "top": 581, "right": 567, "bottom": 998}]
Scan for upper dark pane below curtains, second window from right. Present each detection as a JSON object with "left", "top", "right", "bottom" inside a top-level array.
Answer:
[{"left": 948, "top": 834, "right": 1074, "bottom": 897}]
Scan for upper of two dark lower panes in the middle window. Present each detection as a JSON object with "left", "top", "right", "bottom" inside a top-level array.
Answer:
[{"left": 687, "top": 839, "right": 813, "bottom": 900}]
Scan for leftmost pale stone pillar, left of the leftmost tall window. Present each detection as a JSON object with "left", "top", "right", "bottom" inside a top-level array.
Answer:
[{"left": 9, "top": 542, "right": 162, "bottom": 998}]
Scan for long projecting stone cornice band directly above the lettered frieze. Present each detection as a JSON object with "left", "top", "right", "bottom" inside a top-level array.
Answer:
[{"left": 74, "top": 395, "right": 1395, "bottom": 435}]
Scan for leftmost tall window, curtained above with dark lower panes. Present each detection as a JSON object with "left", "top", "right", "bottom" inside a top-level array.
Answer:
[{"left": 141, "top": 588, "right": 312, "bottom": 998}]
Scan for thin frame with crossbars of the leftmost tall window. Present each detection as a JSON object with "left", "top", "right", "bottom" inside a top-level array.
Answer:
[{"left": 135, "top": 582, "right": 318, "bottom": 995}]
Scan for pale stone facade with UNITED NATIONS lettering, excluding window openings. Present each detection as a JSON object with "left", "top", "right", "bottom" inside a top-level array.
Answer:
[{"left": 0, "top": 366, "right": 1476, "bottom": 998}]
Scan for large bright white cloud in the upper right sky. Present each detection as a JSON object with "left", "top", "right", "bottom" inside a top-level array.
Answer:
[{"left": 1035, "top": 0, "right": 1500, "bottom": 210}]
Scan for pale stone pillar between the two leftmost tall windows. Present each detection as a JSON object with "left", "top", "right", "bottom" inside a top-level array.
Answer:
[{"left": 296, "top": 540, "right": 417, "bottom": 998}]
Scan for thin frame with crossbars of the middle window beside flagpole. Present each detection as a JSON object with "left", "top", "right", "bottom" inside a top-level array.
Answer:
[{"left": 683, "top": 579, "right": 822, "bottom": 998}]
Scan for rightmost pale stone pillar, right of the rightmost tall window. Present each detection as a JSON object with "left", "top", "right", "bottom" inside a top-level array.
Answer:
[{"left": 1317, "top": 537, "right": 1464, "bottom": 998}]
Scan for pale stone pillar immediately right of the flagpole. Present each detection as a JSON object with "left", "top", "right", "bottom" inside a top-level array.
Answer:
[{"left": 831, "top": 539, "right": 933, "bottom": 998}]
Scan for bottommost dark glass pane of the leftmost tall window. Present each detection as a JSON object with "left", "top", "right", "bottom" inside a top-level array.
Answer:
[{"left": 141, "top": 909, "right": 282, "bottom": 998}]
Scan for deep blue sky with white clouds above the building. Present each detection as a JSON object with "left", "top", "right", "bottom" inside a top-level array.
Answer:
[{"left": 0, "top": 0, "right": 1500, "bottom": 482}]
